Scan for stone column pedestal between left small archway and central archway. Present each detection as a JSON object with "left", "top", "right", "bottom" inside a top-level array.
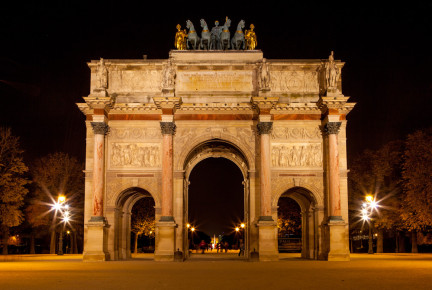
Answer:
[{"left": 154, "top": 217, "right": 177, "bottom": 262}]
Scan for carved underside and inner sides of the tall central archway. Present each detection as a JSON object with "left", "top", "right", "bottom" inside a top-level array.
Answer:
[{"left": 184, "top": 139, "right": 249, "bottom": 258}]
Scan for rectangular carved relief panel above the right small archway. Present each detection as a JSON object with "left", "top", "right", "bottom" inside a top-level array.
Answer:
[{"left": 271, "top": 143, "right": 322, "bottom": 168}]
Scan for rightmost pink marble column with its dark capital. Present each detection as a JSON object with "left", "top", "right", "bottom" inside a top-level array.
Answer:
[{"left": 324, "top": 122, "right": 342, "bottom": 220}]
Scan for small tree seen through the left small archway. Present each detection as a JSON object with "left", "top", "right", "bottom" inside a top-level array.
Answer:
[{"left": 131, "top": 197, "right": 155, "bottom": 253}]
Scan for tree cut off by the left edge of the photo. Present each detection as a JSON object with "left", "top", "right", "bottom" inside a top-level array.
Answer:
[{"left": 0, "top": 128, "right": 29, "bottom": 255}]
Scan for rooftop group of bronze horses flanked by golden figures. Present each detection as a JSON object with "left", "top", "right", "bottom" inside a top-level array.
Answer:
[{"left": 174, "top": 17, "right": 258, "bottom": 50}]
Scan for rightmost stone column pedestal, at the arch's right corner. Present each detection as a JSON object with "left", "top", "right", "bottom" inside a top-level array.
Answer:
[{"left": 327, "top": 217, "right": 350, "bottom": 261}]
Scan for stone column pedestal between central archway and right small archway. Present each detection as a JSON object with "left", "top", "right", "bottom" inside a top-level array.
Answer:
[{"left": 257, "top": 216, "right": 279, "bottom": 262}]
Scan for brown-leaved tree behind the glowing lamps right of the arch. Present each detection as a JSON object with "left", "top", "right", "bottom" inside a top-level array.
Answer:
[{"left": 349, "top": 140, "right": 404, "bottom": 252}]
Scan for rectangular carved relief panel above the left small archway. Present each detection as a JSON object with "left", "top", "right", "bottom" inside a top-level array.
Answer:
[{"left": 110, "top": 143, "right": 161, "bottom": 168}]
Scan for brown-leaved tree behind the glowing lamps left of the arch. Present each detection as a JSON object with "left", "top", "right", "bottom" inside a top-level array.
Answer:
[{"left": 30, "top": 152, "right": 84, "bottom": 254}]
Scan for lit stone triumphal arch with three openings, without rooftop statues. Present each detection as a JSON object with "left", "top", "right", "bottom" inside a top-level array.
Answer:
[{"left": 78, "top": 21, "right": 354, "bottom": 261}]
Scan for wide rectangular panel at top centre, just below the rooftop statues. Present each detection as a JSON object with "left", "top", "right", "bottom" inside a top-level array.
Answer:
[{"left": 176, "top": 71, "right": 253, "bottom": 92}]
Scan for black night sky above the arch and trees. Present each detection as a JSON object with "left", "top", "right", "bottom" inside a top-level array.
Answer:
[{"left": 0, "top": 0, "right": 432, "bottom": 232}]
